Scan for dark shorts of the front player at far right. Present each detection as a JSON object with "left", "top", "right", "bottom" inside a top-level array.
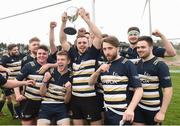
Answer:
[{"left": 134, "top": 106, "right": 158, "bottom": 125}]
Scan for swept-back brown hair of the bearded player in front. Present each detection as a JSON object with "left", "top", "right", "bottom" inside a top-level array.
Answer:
[{"left": 102, "top": 36, "right": 120, "bottom": 47}]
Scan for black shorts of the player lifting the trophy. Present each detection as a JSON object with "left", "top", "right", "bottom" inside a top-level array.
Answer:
[{"left": 71, "top": 96, "right": 101, "bottom": 122}]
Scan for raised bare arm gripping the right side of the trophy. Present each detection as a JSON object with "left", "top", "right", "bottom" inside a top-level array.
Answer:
[{"left": 79, "top": 8, "right": 102, "bottom": 49}]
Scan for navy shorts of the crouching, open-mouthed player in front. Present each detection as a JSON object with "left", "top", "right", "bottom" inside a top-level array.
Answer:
[{"left": 38, "top": 103, "right": 69, "bottom": 121}]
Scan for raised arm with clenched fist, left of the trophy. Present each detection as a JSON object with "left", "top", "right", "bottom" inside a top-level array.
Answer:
[{"left": 49, "top": 22, "right": 57, "bottom": 54}]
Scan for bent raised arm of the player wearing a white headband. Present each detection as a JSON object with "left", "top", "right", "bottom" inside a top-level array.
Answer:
[{"left": 152, "top": 30, "right": 176, "bottom": 56}]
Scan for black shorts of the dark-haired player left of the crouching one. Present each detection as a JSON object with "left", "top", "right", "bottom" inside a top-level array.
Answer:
[{"left": 21, "top": 99, "right": 41, "bottom": 120}]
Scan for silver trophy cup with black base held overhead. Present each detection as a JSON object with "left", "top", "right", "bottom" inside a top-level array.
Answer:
[{"left": 64, "top": 6, "right": 78, "bottom": 35}]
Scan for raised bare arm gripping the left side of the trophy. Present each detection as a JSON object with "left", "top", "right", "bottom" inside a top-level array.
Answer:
[{"left": 59, "top": 12, "right": 70, "bottom": 51}]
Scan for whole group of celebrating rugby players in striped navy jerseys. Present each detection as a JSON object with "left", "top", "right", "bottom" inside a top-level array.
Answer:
[{"left": 0, "top": 8, "right": 176, "bottom": 125}]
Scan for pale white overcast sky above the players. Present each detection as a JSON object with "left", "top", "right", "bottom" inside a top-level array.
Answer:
[{"left": 0, "top": 0, "right": 180, "bottom": 45}]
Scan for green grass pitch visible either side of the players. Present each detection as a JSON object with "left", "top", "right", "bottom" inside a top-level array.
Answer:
[{"left": 0, "top": 66, "right": 180, "bottom": 125}]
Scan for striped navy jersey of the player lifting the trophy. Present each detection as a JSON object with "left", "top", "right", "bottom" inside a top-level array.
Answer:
[{"left": 69, "top": 45, "right": 100, "bottom": 97}]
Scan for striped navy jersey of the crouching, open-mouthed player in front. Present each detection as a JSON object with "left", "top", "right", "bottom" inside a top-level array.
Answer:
[{"left": 42, "top": 68, "right": 71, "bottom": 103}]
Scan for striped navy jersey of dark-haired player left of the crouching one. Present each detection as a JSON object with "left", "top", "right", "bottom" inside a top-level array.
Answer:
[{"left": 16, "top": 61, "right": 43, "bottom": 100}]
